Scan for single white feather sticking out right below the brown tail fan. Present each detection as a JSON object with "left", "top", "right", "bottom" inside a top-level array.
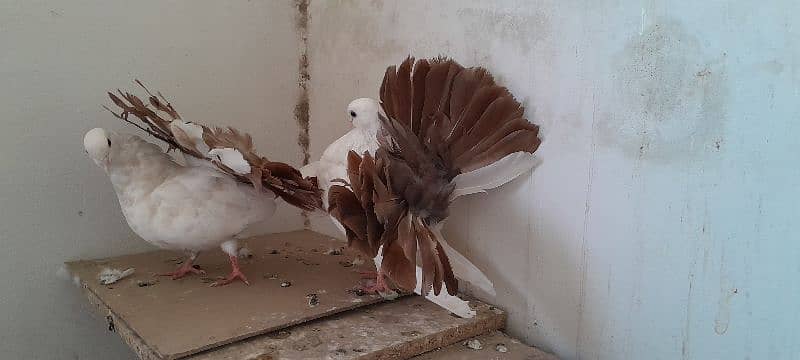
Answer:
[{"left": 450, "top": 151, "right": 538, "bottom": 201}]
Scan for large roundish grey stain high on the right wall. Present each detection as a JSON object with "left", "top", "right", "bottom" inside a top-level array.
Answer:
[{"left": 596, "top": 21, "right": 728, "bottom": 163}]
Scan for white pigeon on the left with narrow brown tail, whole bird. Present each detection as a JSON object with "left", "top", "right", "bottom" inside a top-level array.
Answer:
[{"left": 83, "top": 84, "right": 321, "bottom": 286}]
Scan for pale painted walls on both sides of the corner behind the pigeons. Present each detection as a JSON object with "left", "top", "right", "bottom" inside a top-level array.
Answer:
[{"left": 0, "top": 0, "right": 800, "bottom": 360}]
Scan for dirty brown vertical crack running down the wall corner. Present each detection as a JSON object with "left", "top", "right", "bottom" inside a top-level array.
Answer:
[{"left": 294, "top": 0, "right": 311, "bottom": 229}]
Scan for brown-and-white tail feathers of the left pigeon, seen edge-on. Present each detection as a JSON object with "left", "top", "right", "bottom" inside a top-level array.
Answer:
[{"left": 107, "top": 80, "right": 322, "bottom": 210}]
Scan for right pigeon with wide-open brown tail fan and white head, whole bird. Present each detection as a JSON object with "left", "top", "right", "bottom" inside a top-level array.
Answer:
[{"left": 301, "top": 58, "right": 541, "bottom": 317}]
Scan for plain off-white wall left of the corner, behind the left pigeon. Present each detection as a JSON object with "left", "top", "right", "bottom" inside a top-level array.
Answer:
[{"left": 0, "top": 0, "right": 302, "bottom": 359}]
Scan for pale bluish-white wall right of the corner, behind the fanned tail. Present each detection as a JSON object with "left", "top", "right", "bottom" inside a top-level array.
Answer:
[{"left": 310, "top": 0, "right": 800, "bottom": 360}]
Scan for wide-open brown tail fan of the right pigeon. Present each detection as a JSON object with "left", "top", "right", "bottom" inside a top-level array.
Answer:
[{"left": 329, "top": 58, "right": 540, "bottom": 294}]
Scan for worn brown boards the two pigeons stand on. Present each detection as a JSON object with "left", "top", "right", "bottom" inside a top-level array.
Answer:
[{"left": 67, "top": 231, "right": 520, "bottom": 360}]
